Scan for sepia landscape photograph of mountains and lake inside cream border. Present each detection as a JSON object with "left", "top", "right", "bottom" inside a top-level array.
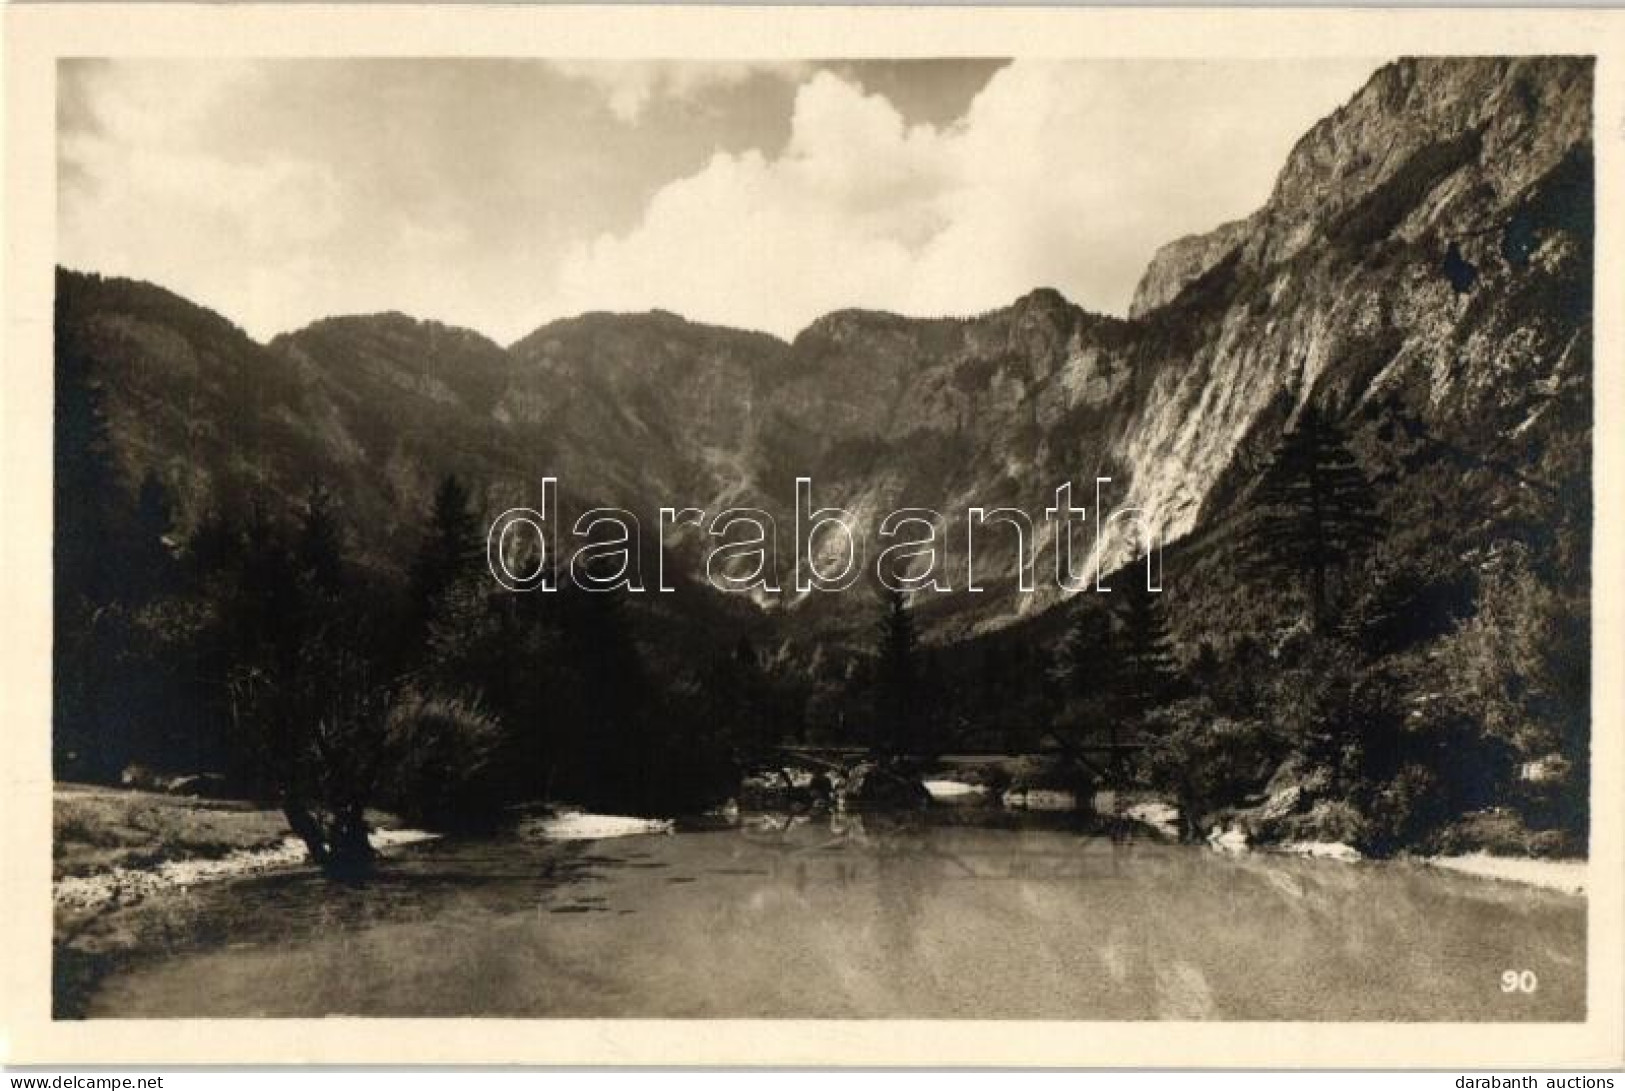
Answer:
[{"left": 7, "top": 0, "right": 1619, "bottom": 1063}]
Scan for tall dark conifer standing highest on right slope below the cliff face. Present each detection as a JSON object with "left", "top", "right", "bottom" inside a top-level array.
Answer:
[{"left": 1248, "top": 403, "right": 1380, "bottom": 631}]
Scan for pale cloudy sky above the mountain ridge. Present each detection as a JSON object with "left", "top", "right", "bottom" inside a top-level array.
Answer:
[{"left": 57, "top": 59, "right": 1378, "bottom": 343}]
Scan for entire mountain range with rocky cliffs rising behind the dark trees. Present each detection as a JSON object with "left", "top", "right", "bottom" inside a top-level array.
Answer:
[{"left": 57, "top": 57, "right": 1593, "bottom": 653}]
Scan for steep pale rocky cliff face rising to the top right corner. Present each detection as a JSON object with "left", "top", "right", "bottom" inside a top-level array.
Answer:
[{"left": 1113, "top": 59, "right": 1591, "bottom": 598}]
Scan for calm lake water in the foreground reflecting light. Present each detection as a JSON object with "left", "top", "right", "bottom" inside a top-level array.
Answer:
[{"left": 79, "top": 813, "right": 1586, "bottom": 1021}]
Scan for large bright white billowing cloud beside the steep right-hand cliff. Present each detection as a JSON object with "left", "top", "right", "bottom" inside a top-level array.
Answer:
[{"left": 551, "top": 62, "right": 1375, "bottom": 337}]
